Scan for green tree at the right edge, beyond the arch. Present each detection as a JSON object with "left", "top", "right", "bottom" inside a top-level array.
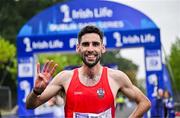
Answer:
[{"left": 169, "top": 38, "right": 180, "bottom": 91}]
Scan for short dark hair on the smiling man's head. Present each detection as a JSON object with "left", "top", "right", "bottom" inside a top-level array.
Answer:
[{"left": 78, "top": 25, "right": 104, "bottom": 43}]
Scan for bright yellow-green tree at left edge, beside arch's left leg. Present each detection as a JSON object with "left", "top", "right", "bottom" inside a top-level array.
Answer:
[{"left": 0, "top": 37, "right": 17, "bottom": 106}]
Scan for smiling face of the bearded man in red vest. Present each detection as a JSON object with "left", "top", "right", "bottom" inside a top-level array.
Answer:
[{"left": 77, "top": 33, "right": 105, "bottom": 67}]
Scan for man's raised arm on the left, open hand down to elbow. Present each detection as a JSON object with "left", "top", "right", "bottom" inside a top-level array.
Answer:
[{"left": 26, "top": 61, "right": 61, "bottom": 109}]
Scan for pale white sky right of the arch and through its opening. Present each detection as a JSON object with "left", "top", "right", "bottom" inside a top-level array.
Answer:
[{"left": 110, "top": 0, "right": 180, "bottom": 79}]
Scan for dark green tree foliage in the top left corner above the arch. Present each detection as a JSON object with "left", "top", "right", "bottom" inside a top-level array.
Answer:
[{"left": 0, "top": 0, "right": 65, "bottom": 44}]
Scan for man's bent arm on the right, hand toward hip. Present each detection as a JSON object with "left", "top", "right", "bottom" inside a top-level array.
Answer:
[{"left": 119, "top": 73, "right": 151, "bottom": 118}]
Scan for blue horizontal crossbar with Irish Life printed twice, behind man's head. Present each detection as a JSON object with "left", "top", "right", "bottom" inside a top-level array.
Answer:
[{"left": 17, "top": 29, "right": 160, "bottom": 56}]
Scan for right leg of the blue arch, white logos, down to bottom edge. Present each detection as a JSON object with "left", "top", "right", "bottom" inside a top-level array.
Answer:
[{"left": 145, "top": 47, "right": 164, "bottom": 118}]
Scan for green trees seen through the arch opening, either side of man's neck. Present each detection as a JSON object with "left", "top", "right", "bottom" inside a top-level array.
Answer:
[{"left": 37, "top": 51, "right": 138, "bottom": 85}]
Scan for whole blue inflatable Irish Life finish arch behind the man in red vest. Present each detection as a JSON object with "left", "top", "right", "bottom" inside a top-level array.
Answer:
[{"left": 17, "top": 0, "right": 163, "bottom": 115}]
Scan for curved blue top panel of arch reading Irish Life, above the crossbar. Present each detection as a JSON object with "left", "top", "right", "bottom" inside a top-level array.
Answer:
[{"left": 18, "top": 0, "right": 157, "bottom": 37}]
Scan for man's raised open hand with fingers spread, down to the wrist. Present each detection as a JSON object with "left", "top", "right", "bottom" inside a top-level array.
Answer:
[{"left": 33, "top": 60, "right": 58, "bottom": 95}]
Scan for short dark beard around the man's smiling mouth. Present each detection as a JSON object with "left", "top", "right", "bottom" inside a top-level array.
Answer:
[{"left": 81, "top": 52, "right": 102, "bottom": 68}]
